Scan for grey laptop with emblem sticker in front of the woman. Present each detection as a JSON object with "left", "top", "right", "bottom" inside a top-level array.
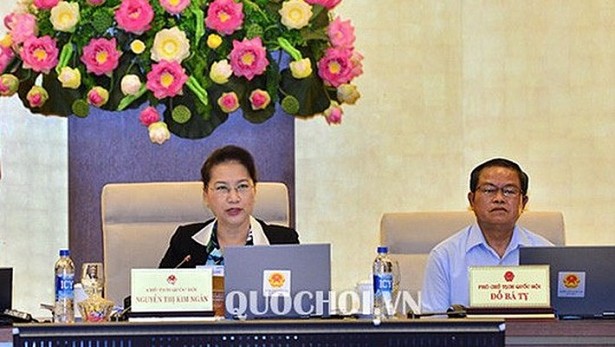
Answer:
[{"left": 224, "top": 244, "right": 331, "bottom": 319}]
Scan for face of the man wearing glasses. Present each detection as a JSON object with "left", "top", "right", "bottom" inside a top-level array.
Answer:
[{"left": 468, "top": 166, "right": 527, "bottom": 230}]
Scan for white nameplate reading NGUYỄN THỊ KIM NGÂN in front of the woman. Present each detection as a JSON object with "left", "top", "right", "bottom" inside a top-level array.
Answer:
[{"left": 130, "top": 268, "right": 213, "bottom": 312}]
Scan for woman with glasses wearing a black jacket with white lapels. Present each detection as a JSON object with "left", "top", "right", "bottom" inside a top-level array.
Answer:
[{"left": 159, "top": 146, "right": 299, "bottom": 268}]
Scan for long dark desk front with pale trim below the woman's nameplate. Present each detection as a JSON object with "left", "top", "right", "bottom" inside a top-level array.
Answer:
[{"left": 13, "top": 319, "right": 504, "bottom": 347}]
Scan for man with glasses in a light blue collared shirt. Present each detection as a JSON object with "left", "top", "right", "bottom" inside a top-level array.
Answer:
[{"left": 421, "top": 158, "right": 552, "bottom": 313}]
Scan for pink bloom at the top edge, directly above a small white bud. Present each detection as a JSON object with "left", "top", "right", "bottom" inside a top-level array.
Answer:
[{"left": 115, "top": 0, "right": 154, "bottom": 35}]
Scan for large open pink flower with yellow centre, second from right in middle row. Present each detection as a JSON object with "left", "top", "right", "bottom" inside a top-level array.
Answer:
[{"left": 230, "top": 36, "right": 269, "bottom": 80}]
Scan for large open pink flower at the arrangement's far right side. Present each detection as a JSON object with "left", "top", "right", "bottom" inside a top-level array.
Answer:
[{"left": 318, "top": 48, "right": 353, "bottom": 88}]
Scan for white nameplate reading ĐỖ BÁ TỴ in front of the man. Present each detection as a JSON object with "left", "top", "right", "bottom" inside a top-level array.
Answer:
[{"left": 470, "top": 265, "right": 551, "bottom": 308}]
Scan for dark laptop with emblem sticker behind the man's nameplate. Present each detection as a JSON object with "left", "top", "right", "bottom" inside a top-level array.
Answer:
[{"left": 519, "top": 246, "right": 615, "bottom": 319}]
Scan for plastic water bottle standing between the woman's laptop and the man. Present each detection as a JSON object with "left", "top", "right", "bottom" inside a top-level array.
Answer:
[{"left": 372, "top": 246, "right": 395, "bottom": 320}]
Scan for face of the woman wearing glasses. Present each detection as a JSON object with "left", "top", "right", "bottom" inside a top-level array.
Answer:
[{"left": 203, "top": 161, "right": 256, "bottom": 228}]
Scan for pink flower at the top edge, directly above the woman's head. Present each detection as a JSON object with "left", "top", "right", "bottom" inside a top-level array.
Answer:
[{"left": 205, "top": 0, "right": 243, "bottom": 35}]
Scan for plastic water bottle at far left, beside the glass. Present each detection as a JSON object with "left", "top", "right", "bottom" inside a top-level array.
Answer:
[{"left": 53, "top": 249, "right": 75, "bottom": 323}]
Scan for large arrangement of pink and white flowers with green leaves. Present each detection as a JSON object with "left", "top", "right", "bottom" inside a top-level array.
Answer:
[{"left": 0, "top": 0, "right": 363, "bottom": 143}]
